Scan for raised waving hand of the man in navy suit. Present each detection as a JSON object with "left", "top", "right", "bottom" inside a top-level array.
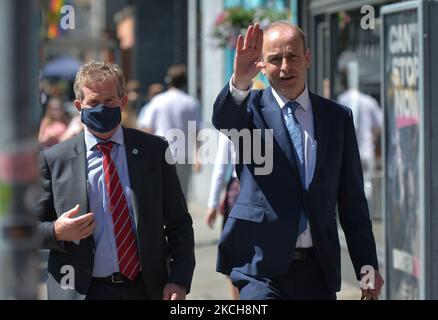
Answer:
[{"left": 233, "top": 23, "right": 265, "bottom": 90}]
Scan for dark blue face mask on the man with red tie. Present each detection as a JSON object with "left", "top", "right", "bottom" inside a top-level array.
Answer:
[{"left": 81, "top": 104, "right": 122, "bottom": 133}]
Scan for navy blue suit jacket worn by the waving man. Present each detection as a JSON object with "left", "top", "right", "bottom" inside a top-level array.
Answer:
[{"left": 213, "top": 84, "right": 378, "bottom": 291}]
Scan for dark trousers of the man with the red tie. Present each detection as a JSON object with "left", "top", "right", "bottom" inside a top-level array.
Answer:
[{"left": 85, "top": 273, "right": 149, "bottom": 300}]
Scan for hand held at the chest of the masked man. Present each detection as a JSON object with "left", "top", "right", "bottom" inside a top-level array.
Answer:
[{"left": 54, "top": 205, "right": 96, "bottom": 241}]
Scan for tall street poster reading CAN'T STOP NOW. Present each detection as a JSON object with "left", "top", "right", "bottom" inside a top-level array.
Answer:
[{"left": 382, "top": 8, "right": 422, "bottom": 299}]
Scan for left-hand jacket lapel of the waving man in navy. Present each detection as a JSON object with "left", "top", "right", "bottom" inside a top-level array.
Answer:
[{"left": 260, "top": 87, "right": 298, "bottom": 169}]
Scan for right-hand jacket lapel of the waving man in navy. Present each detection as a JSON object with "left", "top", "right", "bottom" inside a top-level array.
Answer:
[{"left": 310, "top": 93, "right": 328, "bottom": 183}]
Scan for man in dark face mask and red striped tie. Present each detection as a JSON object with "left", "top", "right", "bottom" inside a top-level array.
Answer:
[{"left": 39, "top": 61, "right": 195, "bottom": 300}]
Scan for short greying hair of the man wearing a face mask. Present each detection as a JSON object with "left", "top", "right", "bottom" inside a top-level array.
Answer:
[{"left": 73, "top": 60, "right": 126, "bottom": 101}]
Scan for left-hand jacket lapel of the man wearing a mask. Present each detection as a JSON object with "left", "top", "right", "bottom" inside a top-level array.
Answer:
[{"left": 66, "top": 133, "right": 90, "bottom": 216}]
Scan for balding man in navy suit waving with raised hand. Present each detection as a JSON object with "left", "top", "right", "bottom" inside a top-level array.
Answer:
[{"left": 213, "top": 22, "right": 383, "bottom": 299}]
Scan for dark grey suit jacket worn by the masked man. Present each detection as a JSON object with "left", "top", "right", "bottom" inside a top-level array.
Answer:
[{"left": 38, "top": 128, "right": 195, "bottom": 300}]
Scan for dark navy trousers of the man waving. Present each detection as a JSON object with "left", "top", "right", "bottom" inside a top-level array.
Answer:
[{"left": 230, "top": 250, "right": 336, "bottom": 300}]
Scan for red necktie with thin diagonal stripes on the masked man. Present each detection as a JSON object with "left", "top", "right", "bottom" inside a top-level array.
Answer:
[{"left": 97, "top": 142, "right": 140, "bottom": 280}]
